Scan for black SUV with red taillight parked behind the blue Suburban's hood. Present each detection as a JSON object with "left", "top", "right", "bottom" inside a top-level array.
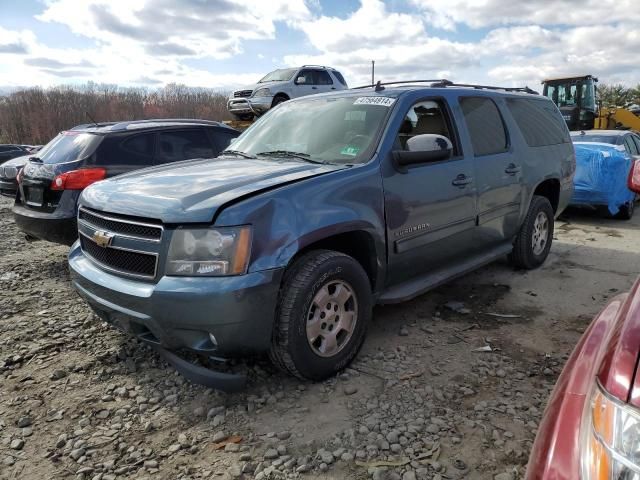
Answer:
[{"left": 13, "top": 119, "right": 240, "bottom": 245}]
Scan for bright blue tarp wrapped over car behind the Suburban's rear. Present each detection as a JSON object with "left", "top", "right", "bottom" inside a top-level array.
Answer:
[{"left": 571, "top": 142, "right": 634, "bottom": 215}]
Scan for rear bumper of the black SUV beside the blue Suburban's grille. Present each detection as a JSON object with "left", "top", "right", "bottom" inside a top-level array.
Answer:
[{"left": 13, "top": 203, "right": 78, "bottom": 245}]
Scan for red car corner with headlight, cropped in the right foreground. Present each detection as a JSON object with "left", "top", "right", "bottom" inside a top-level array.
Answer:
[{"left": 526, "top": 279, "right": 640, "bottom": 480}]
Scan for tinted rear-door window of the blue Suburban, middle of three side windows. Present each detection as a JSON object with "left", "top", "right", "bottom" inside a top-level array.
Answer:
[{"left": 460, "top": 97, "right": 508, "bottom": 157}]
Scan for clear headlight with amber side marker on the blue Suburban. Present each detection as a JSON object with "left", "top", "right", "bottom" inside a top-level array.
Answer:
[{"left": 166, "top": 226, "right": 251, "bottom": 277}]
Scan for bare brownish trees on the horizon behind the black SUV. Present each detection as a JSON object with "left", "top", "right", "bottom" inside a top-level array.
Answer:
[{"left": 0, "top": 82, "right": 229, "bottom": 145}]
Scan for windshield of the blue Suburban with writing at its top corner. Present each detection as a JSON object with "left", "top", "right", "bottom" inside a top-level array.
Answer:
[{"left": 229, "top": 96, "right": 395, "bottom": 164}]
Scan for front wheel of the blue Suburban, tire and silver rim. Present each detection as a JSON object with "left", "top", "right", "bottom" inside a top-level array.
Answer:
[{"left": 270, "top": 250, "right": 373, "bottom": 380}]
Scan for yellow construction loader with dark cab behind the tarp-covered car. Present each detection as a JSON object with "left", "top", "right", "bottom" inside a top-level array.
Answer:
[{"left": 542, "top": 75, "right": 640, "bottom": 131}]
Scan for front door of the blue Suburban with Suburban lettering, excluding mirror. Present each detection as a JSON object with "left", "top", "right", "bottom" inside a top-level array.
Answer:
[{"left": 383, "top": 99, "right": 476, "bottom": 285}]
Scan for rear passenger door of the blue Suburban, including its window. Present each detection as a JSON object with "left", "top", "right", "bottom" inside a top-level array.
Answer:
[{"left": 459, "top": 96, "right": 523, "bottom": 248}]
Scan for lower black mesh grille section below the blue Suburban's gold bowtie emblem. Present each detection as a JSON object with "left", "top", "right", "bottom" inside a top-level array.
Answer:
[{"left": 80, "top": 234, "right": 157, "bottom": 278}]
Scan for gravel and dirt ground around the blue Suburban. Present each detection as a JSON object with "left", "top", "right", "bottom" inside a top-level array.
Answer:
[{"left": 0, "top": 199, "right": 640, "bottom": 480}]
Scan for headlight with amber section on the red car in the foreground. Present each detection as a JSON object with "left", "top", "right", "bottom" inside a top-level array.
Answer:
[{"left": 581, "top": 385, "right": 640, "bottom": 480}]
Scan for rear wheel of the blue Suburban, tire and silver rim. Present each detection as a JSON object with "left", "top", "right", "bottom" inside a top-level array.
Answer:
[{"left": 509, "top": 195, "right": 554, "bottom": 270}]
